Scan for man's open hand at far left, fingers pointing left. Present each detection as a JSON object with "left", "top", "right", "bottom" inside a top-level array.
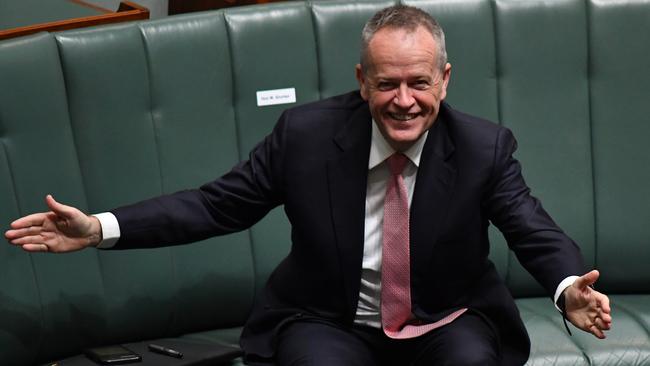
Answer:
[{"left": 5, "top": 195, "right": 102, "bottom": 253}]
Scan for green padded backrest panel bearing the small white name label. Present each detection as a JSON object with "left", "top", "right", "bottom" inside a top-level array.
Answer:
[{"left": 225, "top": 2, "right": 319, "bottom": 287}]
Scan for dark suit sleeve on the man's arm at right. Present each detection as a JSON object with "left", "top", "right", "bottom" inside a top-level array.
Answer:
[{"left": 484, "top": 129, "right": 584, "bottom": 297}]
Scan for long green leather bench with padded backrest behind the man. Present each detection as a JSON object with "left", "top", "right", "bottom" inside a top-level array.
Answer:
[{"left": 0, "top": 0, "right": 650, "bottom": 365}]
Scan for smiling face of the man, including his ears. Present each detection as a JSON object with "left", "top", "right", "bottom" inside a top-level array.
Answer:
[{"left": 356, "top": 27, "right": 451, "bottom": 151}]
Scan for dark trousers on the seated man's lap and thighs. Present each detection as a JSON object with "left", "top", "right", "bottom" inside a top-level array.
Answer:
[{"left": 275, "top": 313, "right": 500, "bottom": 366}]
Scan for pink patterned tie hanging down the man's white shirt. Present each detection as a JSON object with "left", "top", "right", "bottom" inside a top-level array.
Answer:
[{"left": 381, "top": 153, "right": 467, "bottom": 339}]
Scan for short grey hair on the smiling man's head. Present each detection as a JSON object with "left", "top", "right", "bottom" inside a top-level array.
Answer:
[{"left": 361, "top": 4, "right": 447, "bottom": 73}]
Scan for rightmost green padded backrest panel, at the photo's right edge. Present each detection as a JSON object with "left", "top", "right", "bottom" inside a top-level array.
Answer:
[{"left": 589, "top": 0, "right": 650, "bottom": 293}]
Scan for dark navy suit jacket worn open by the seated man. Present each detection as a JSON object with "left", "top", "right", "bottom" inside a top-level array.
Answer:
[{"left": 113, "top": 92, "right": 584, "bottom": 365}]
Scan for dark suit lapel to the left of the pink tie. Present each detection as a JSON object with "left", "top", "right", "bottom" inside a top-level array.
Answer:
[{"left": 327, "top": 103, "right": 372, "bottom": 320}]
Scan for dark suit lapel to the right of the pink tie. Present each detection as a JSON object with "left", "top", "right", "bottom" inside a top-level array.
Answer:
[{"left": 410, "top": 113, "right": 457, "bottom": 303}]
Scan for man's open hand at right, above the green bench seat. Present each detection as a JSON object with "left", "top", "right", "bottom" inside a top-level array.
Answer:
[{"left": 564, "top": 270, "right": 612, "bottom": 339}]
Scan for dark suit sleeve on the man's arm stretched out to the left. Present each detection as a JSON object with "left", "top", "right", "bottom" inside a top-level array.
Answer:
[{"left": 111, "top": 113, "right": 286, "bottom": 249}]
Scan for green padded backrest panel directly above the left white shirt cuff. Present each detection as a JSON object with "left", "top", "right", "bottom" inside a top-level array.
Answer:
[{"left": 57, "top": 25, "right": 162, "bottom": 210}]
